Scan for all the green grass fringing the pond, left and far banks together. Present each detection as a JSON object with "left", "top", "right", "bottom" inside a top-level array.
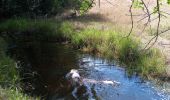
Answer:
[{"left": 0, "top": 19, "right": 165, "bottom": 100}]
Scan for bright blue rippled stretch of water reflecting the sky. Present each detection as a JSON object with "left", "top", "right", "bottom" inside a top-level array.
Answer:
[{"left": 77, "top": 55, "right": 170, "bottom": 100}]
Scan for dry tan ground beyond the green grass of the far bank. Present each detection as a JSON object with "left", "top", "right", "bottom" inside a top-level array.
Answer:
[{"left": 71, "top": 0, "right": 170, "bottom": 76}]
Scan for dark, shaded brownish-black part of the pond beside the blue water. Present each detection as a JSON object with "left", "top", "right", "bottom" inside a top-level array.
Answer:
[{"left": 11, "top": 42, "right": 78, "bottom": 99}]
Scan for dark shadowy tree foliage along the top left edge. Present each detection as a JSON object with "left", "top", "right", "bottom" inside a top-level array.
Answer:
[{"left": 0, "top": 0, "right": 92, "bottom": 18}]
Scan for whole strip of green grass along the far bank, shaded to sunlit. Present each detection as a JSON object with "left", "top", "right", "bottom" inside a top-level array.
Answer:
[{"left": 0, "top": 19, "right": 165, "bottom": 77}]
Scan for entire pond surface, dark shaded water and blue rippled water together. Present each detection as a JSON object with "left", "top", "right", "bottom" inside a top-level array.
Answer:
[{"left": 11, "top": 42, "right": 170, "bottom": 100}]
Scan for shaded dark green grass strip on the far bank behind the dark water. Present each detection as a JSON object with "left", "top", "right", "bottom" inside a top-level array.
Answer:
[{"left": 0, "top": 18, "right": 73, "bottom": 41}]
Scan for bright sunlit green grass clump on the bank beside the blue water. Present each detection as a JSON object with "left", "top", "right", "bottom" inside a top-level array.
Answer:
[{"left": 71, "top": 28, "right": 165, "bottom": 77}]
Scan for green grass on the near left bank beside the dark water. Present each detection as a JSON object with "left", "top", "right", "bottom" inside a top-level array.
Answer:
[{"left": 0, "top": 37, "right": 36, "bottom": 100}]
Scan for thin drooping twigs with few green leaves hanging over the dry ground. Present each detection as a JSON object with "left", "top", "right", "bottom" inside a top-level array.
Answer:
[{"left": 126, "top": 0, "right": 170, "bottom": 50}]
